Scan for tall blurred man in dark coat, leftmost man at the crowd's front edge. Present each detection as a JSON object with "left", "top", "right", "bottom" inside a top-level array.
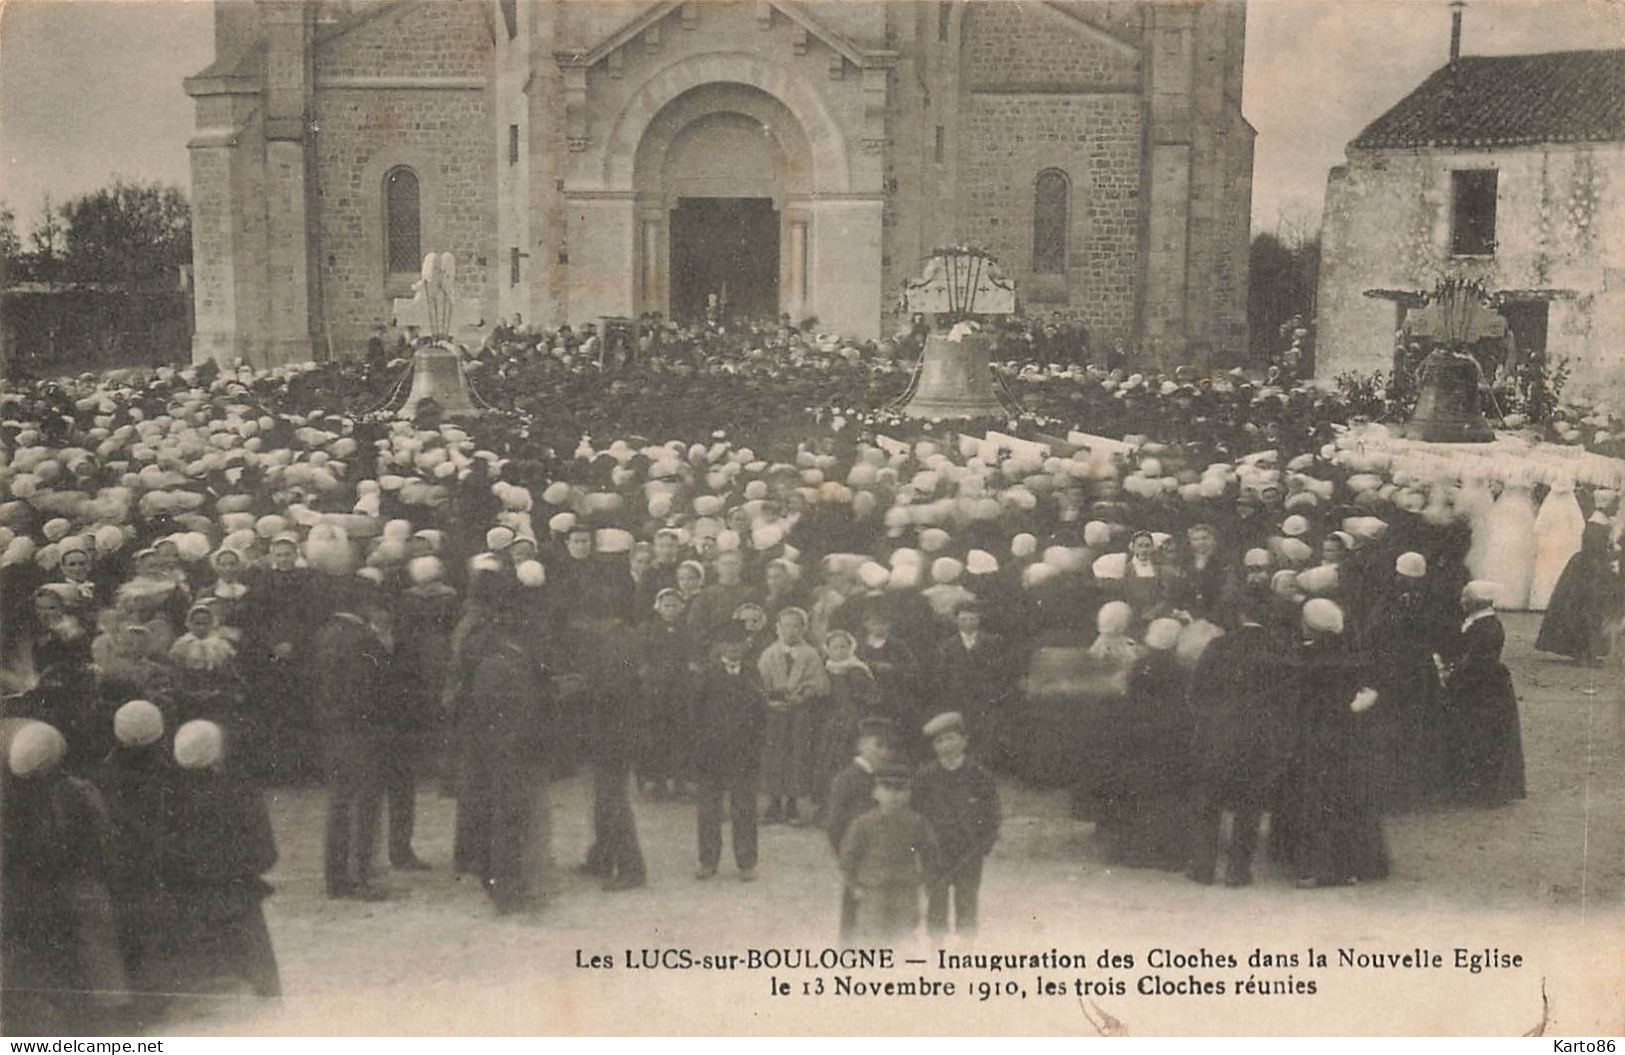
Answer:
[{"left": 314, "top": 579, "right": 395, "bottom": 901}]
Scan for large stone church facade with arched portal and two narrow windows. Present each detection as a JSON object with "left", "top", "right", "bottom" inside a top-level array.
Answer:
[{"left": 185, "top": 0, "right": 1253, "bottom": 364}]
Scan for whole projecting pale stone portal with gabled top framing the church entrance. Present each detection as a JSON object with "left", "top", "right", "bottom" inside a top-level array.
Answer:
[{"left": 566, "top": 52, "right": 884, "bottom": 336}]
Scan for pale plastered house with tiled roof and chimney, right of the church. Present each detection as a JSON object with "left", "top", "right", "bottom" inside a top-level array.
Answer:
[{"left": 1316, "top": 34, "right": 1625, "bottom": 398}]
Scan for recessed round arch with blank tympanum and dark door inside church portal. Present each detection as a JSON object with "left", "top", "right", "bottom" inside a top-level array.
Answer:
[{"left": 634, "top": 83, "right": 813, "bottom": 320}]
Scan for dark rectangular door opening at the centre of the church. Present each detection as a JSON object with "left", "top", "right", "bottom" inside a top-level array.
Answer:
[{"left": 670, "top": 198, "right": 780, "bottom": 322}]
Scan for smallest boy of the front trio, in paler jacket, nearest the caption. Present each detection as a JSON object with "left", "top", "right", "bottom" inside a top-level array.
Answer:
[{"left": 840, "top": 766, "right": 938, "bottom": 944}]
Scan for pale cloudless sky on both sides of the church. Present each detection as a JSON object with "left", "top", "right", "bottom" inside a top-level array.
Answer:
[{"left": 0, "top": 0, "right": 1625, "bottom": 237}]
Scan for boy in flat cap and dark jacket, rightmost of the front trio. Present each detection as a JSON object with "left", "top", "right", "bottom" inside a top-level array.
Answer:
[{"left": 913, "top": 710, "right": 999, "bottom": 941}]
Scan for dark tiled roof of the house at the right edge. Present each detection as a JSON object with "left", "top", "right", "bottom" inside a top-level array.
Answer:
[{"left": 1349, "top": 50, "right": 1625, "bottom": 150}]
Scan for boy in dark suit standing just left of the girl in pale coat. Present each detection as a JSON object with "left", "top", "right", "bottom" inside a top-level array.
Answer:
[{"left": 691, "top": 624, "right": 767, "bottom": 883}]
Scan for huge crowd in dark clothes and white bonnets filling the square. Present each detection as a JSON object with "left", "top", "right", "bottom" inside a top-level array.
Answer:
[{"left": 0, "top": 318, "right": 1620, "bottom": 1032}]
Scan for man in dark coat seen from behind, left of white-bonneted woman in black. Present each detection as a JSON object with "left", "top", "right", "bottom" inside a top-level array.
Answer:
[{"left": 1188, "top": 606, "right": 1285, "bottom": 886}]
